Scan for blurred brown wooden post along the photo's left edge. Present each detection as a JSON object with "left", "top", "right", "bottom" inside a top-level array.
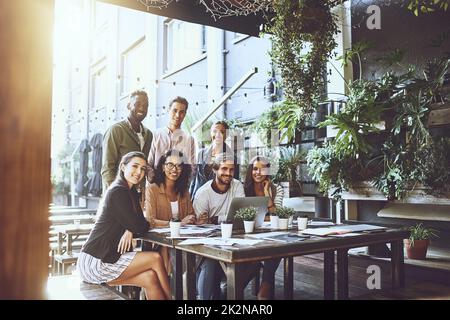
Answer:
[{"left": 0, "top": 0, "right": 54, "bottom": 299}]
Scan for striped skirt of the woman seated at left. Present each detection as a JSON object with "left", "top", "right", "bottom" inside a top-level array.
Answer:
[{"left": 77, "top": 251, "right": 137, "bottom": 284}]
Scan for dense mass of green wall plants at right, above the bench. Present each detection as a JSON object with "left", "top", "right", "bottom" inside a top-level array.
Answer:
[{"left": 307, "top": 59, "right": 450, "bottom": 199}]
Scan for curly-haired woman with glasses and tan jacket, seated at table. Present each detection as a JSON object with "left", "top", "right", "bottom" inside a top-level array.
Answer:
[{"left": 145, "top": 150, "right": 196, "bottom": 273}]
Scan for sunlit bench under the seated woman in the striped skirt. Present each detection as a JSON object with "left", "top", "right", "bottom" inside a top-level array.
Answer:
[{"left": 47, "top": 274, "right": 128, "bottom": 300}]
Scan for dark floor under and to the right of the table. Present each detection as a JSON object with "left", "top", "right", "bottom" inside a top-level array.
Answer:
[{"left": 245, "top": 254, "right": 450, "bottom": 300}]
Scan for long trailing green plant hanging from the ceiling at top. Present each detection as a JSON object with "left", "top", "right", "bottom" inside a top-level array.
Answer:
[{"left": 269, "top": 0, "right": 341, "bottom": 138}]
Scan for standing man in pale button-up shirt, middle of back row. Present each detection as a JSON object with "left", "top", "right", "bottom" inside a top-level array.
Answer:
[{"left": 147, "top": 97, "right": 197, "bottom": 182}]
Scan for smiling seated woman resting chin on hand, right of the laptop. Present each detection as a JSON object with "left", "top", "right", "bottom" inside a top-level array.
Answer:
[{"left": 244, "top": 156, "right": 284, "bottom": 300}]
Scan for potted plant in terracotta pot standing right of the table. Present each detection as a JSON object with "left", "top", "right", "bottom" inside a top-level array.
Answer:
[{"left": 404, "top": 223, "right": 437, "bottom": 260}]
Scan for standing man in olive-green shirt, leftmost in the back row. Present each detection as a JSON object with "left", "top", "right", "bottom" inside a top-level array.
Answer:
[{"left": 101, "top": 91, "right": 153, "bottom": 194}]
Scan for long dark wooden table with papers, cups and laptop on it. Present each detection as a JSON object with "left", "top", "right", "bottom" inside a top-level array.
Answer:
[{"left": 141, "top": 225, "right": 409, "bottom": 300}]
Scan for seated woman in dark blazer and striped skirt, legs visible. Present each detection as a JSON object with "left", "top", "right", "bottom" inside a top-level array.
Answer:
[{"left": 77, "top": 152, "right": 170, "bottom": 300}]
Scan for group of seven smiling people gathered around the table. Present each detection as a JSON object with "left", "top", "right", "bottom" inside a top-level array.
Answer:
[{"left": 77, "top": 91, "right": 283, "bottom": 300}]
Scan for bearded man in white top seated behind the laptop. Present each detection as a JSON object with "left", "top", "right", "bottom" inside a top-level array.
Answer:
[{"left": 193, "top": 153, "right": 245, "bottom": 300}]
